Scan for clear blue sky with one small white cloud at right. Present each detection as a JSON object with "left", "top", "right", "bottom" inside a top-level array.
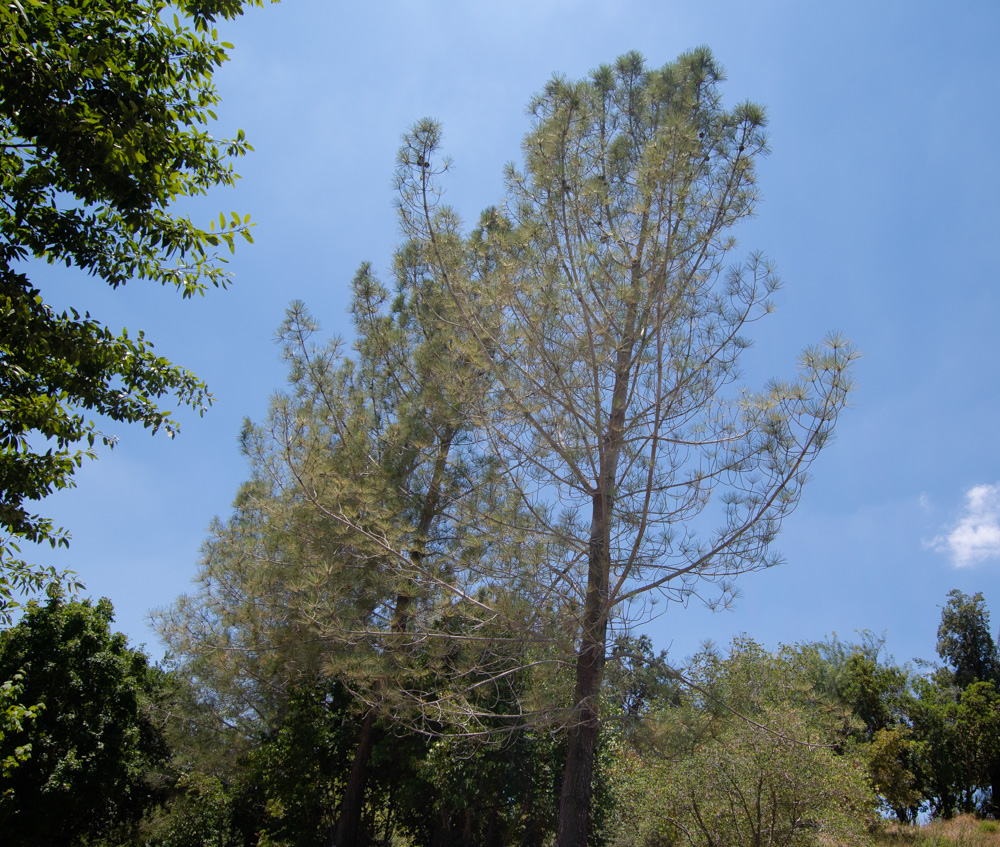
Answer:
[{"left": 21, "top": 0, "right": 1000, "bottom": 676}]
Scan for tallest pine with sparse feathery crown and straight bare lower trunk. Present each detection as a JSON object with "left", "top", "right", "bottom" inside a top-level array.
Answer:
[{"left": 402, "top": 49, "right": 854, "bottom": 847}]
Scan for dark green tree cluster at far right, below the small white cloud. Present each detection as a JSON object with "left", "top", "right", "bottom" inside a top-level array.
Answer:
[{"left": 802, "top": 590, "right": 1000, "bottom": 822}]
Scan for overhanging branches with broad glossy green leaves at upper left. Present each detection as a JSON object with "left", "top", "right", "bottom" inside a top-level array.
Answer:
[{"left": 0, "top": 0, "right": 278, "bottom": 622}]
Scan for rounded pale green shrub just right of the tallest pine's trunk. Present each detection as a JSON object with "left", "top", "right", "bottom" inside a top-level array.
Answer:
[{"left": 617, "top": 639, "right": 875, "bottom": 847}]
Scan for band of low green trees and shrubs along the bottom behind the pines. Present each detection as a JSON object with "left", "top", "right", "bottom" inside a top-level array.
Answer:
[{"left": 0, "top": 595, "right": 1000, "bottom": 847}]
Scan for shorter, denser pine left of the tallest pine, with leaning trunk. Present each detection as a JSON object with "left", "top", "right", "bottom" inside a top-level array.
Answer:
[{"left": 159, "top": 194, "right": 520, "bottom": 844}]
